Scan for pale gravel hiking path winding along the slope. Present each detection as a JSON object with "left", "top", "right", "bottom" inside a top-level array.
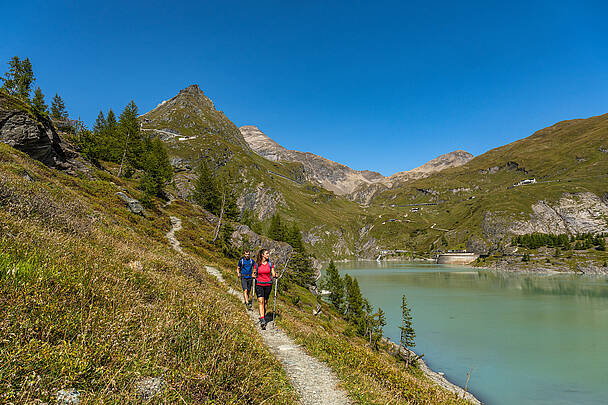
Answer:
[{"left": 167, "top": 217, "right": 350, "bottom": 405}]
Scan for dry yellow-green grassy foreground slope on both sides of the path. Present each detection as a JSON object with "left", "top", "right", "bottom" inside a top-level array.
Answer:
[{"left": 0, "top": 144, "right": 476, "bottom": 404}]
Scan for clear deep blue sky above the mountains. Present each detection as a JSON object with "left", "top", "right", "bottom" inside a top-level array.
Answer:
[{"left": 0, "top": 0, "right": 608, "bottom": 175}]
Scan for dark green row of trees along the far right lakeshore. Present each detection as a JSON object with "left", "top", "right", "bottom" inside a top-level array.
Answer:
[{"left": 511, "top": 232, "right": 606, "bottom": 250}]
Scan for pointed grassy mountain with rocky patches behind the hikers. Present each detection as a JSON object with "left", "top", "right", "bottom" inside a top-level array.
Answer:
[{"left": 140, "top": 86, "right": 380, "bottom": 257}]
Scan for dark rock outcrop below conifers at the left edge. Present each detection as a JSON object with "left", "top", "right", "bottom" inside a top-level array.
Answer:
[{"left": 0, "top": 93, "right": 78, "bottom": 170}]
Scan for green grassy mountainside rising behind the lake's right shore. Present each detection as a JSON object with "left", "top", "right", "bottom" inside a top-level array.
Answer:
[{"left": 372, "top": 114, "right": 608, "bottom": 252}]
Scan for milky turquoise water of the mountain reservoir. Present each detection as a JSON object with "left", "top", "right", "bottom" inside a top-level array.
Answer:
[{"left": 337, "top": 262, "right": 608, "bottom": 404}]
